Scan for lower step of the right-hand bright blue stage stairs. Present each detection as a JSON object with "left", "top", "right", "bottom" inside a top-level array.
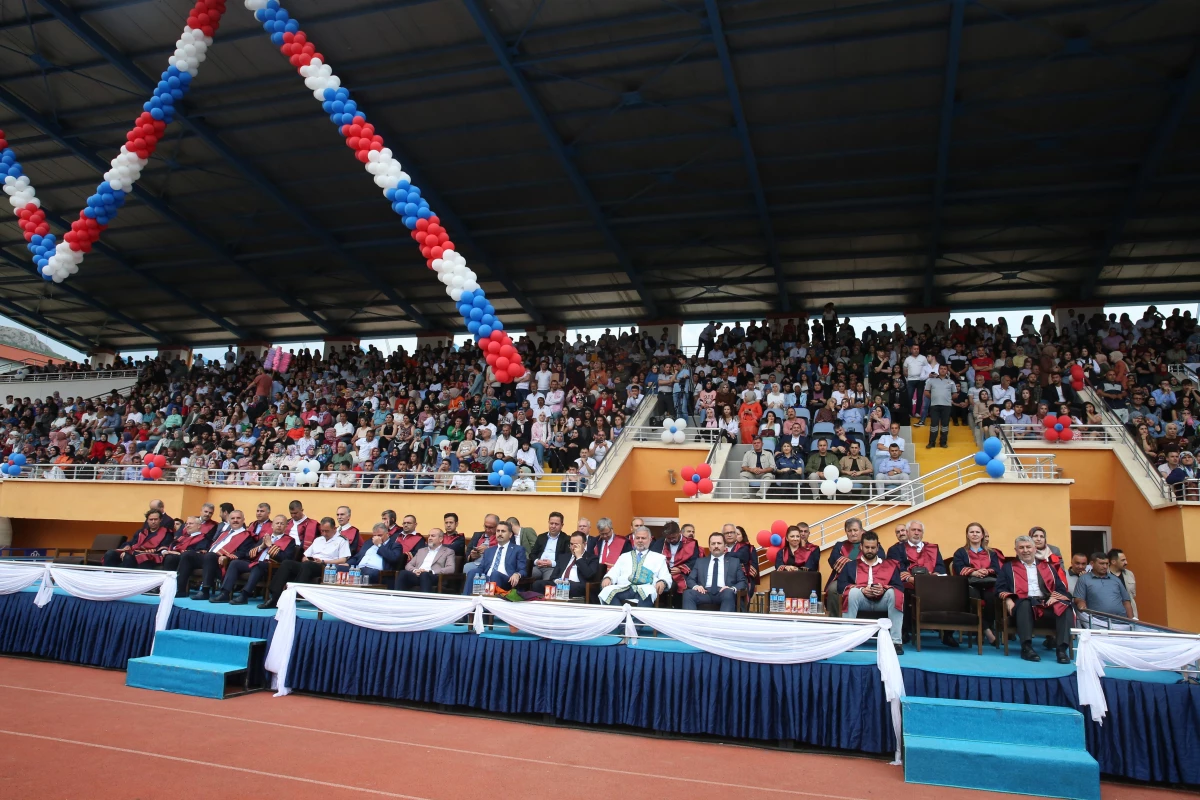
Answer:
[{"left": 904, "top": 733, "right": 1100, "bottom": 800}]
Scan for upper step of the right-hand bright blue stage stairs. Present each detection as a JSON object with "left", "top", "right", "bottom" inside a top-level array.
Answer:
[{"left": 904, "top": 697, "right": 1087, "bottom": 750}]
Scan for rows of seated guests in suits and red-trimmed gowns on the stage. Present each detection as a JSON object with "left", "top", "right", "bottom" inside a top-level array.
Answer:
[{"left": 103, "top": 499, "right": 1136, "bottom": 663}]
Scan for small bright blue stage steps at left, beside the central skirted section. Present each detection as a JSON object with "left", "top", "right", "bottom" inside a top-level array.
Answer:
[{"left": 125, "top": 631, "right": 266, "bottom": 699}]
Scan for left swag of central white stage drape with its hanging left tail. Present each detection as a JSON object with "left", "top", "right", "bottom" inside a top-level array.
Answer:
[{"left": 265, "top": 583, "right": 475, "bottom": 697}]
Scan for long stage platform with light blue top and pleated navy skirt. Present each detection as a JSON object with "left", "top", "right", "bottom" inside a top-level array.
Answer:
[{"left": 0, "top": 590, "right": 1200, "bottom": 786}]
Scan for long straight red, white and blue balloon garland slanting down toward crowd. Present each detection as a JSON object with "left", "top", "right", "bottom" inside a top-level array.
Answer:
[{"left": 245, "top": 0, "right": 527, "bottom": 384}]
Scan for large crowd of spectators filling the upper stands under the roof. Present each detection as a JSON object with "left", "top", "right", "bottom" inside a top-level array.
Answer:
[{"left": 2, "top": 305, "right": 1200, "bottom": 497}]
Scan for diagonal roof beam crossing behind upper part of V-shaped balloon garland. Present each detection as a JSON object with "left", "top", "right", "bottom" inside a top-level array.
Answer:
[{"left": 31, "top": 0, "right": 431, "bottom": 332}]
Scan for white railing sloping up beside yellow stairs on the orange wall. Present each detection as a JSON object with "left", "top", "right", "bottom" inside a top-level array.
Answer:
[{"left": 809, "top": 452, "right": 1061, "bottom": 547}]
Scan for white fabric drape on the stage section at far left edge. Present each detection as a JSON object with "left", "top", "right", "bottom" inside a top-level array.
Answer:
[{"left": 0, "top": 561, "right": 175, "bottom": 631}]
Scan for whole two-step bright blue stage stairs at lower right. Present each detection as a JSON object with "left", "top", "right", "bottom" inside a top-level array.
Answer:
[{"left": 902, "top": 697, "right": 1100, "bottom": 800}]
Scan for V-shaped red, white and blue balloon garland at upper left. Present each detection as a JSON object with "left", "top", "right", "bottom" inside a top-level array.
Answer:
[{"left": 0, "top": 0, "right": 224, "bottom": 283}]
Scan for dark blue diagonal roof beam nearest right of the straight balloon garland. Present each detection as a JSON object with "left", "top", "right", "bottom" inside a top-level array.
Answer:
[{"left": 462, "top": 0, "right": 658, "bottom": 317}]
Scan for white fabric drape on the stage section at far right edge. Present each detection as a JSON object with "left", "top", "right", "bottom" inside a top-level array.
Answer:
[{"left": 1074, "top": 630, "right": 1200, "bottom": 724}]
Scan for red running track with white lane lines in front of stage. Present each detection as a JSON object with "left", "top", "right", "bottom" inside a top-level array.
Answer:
[{"left": 0, "top": 658, "right": 1194, "bottom": 800}]
